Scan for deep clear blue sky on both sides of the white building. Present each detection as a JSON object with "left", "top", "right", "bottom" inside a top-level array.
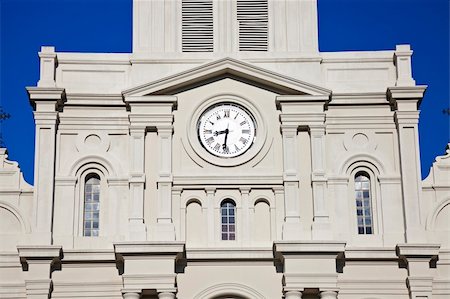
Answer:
[{"left": 0, "top": 0, "right": 450, "bottom": 183}]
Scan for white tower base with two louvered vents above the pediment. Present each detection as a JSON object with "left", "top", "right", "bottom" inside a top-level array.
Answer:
[{"left": 133, "top": 0, "right": 318, "bottom": 58}]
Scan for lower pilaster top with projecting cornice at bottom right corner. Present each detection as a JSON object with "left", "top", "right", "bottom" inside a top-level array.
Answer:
[{"left": 397, "top": 244, "right": 440, "bottom": 299}]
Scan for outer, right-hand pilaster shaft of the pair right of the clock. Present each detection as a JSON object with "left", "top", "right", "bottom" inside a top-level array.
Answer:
[{"left": 309, "top": 124, "right": 332, "bottom": 240}]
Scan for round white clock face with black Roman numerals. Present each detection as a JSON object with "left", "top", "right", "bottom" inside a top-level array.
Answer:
[{"left": 197, "top": 103, "right": 256, "bottom": 158}]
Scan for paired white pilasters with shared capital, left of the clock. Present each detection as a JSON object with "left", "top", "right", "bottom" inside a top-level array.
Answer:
[{"left": 125, "top": 96, "right": 177, "bottom": 241}]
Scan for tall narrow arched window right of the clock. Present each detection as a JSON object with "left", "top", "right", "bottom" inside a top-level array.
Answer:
[{"left": 355, "top": 172, "right": 373, "bottom": 235}]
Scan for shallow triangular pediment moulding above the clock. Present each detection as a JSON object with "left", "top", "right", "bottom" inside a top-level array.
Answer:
[{"left": 123, "top": 58, "right": 331, "bottom": 96}]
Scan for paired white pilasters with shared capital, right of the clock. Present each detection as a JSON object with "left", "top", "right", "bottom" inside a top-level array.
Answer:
[{"left": 277, "top": 95, "right": 332, "bottom": 240}]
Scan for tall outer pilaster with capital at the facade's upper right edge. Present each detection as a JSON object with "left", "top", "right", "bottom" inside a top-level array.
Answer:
[{"left": 388, "top": 86, "right": 426, "bottom": 243}]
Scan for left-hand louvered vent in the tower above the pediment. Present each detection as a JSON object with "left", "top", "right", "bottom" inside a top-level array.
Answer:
[{"left": 182, "top": 0, "right": 214, "bottom": 52}]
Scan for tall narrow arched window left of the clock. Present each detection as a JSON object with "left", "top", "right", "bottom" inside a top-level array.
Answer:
[{"left": 83, "top": 174, "right": 100, "bottom": 237}]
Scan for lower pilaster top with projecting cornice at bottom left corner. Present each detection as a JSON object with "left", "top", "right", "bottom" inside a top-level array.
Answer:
[{"left": 17, "top": 245, "right": 61, "bottom": 299}]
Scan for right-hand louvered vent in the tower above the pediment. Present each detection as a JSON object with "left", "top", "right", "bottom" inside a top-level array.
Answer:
[{"left": 237, "top": 0, "right": 269, "bottom": 51}]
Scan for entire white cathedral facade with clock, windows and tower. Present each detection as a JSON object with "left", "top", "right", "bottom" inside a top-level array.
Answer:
[{"left": 0, "top": 0, "right": 450, "bottom": 299}]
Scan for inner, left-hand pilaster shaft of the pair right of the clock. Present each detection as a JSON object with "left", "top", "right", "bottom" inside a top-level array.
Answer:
[{"left": 281, "top": 124, "right": 303, "bottom": 240}]
